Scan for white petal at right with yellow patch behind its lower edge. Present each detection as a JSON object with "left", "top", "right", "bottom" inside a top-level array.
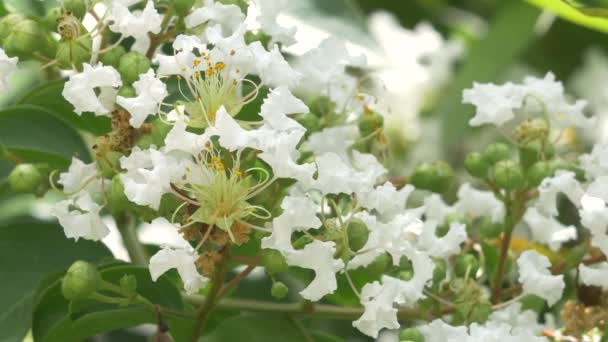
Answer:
[{"left": 523, "top": 207, "right": 577, "bottom": 251}]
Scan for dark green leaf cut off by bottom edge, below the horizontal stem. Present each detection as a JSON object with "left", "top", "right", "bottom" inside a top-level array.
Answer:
[{"left": 204, "top": 315, "right": 309, "bottom": 342}]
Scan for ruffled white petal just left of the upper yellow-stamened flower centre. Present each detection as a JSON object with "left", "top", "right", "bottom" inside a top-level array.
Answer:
[{"left": 116, "top": 69, "right": 169, "bottom": 128}]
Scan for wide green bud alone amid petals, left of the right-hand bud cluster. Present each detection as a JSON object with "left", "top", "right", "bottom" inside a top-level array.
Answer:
[{"left": 410, "top": 160, "right": 454, "bottom": 193}]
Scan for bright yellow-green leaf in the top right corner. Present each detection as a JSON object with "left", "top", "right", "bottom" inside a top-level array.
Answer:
[{"left": 527, "top": 0, "right": 608, "bottom": 32}]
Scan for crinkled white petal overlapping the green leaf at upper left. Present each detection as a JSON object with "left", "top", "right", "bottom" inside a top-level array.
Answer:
[{"left": 62, "top": 63, "right": 122, "bottom": 116}]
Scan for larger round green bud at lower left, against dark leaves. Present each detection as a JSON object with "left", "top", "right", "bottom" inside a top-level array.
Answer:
[{"left": 61, "top": 260, "right": 103, "bottom": 300}]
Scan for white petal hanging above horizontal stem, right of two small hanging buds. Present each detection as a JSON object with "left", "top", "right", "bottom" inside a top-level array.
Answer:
[{"left": 285, "top": 240, "right": 344, "bottom": 301}]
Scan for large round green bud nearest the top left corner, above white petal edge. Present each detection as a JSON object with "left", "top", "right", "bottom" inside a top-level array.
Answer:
[{"left": 4, "top": 19, "right": 45, "bottom": 56}]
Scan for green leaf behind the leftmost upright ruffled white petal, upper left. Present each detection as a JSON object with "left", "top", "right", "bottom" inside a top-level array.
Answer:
[{"left": 17, "top": 80, "right": 112, "bottom": 136}]
